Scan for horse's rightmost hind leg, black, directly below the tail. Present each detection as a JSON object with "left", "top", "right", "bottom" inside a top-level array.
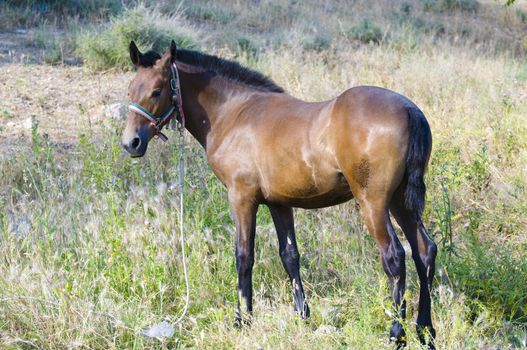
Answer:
[{"left": 390, "top": 188, "right": 437, "bottom": 349}]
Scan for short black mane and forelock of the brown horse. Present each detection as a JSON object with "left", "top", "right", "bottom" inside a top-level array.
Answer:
[{"left": 144, "top": 49, "right": 285, "bottom": 93}]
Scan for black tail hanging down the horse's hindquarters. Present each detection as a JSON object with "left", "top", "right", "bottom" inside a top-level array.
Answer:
[{"left": 404, "top": 107, "right": 432, "bottom": 216}]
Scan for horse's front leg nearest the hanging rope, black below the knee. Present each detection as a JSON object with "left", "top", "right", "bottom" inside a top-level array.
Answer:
[{"left": 229, "top": 190, "right": 258, "bottom": 327}]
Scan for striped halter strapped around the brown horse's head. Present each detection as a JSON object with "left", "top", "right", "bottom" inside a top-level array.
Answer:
[{"left": 128, "top": 63, "right": 185, "bottom": 142}]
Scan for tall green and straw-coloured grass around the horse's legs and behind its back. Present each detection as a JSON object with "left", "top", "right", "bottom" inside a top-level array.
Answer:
[{"left": 0, "top": 46, "right": 527, "bottom": 349}]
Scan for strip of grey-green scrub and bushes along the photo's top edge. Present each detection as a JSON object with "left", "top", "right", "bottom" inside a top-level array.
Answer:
[{"left": 5, "top": 0, "right": 527, "bottom": 70}]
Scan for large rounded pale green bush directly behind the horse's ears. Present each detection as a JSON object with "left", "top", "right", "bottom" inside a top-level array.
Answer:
[{"left": 77, "top": 6, "right": 198, "bottom": 70}]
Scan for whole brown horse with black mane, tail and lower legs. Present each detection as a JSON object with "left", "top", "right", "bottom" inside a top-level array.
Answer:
[{"left": 123, "top": 42, "right": 437, "bottom": 348}]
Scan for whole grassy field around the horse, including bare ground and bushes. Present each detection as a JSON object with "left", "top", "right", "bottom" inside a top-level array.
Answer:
[{"left": 0, "top": 0, "right": 527, "bottom": 349}]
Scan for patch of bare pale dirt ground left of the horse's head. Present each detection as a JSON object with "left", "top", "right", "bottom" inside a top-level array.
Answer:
[{"left": 0, "top": 33, "right": 132, "bottom": 156}]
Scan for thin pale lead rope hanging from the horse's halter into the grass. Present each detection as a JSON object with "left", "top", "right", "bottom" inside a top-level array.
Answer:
[{"left": 173, "top": 124, "right": 190, "bottom": 326}]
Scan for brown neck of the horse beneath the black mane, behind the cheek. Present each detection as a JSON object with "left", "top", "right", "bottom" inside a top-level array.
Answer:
[{"left": 178, "top": 64, "right": 252, "bottom": 149}]
